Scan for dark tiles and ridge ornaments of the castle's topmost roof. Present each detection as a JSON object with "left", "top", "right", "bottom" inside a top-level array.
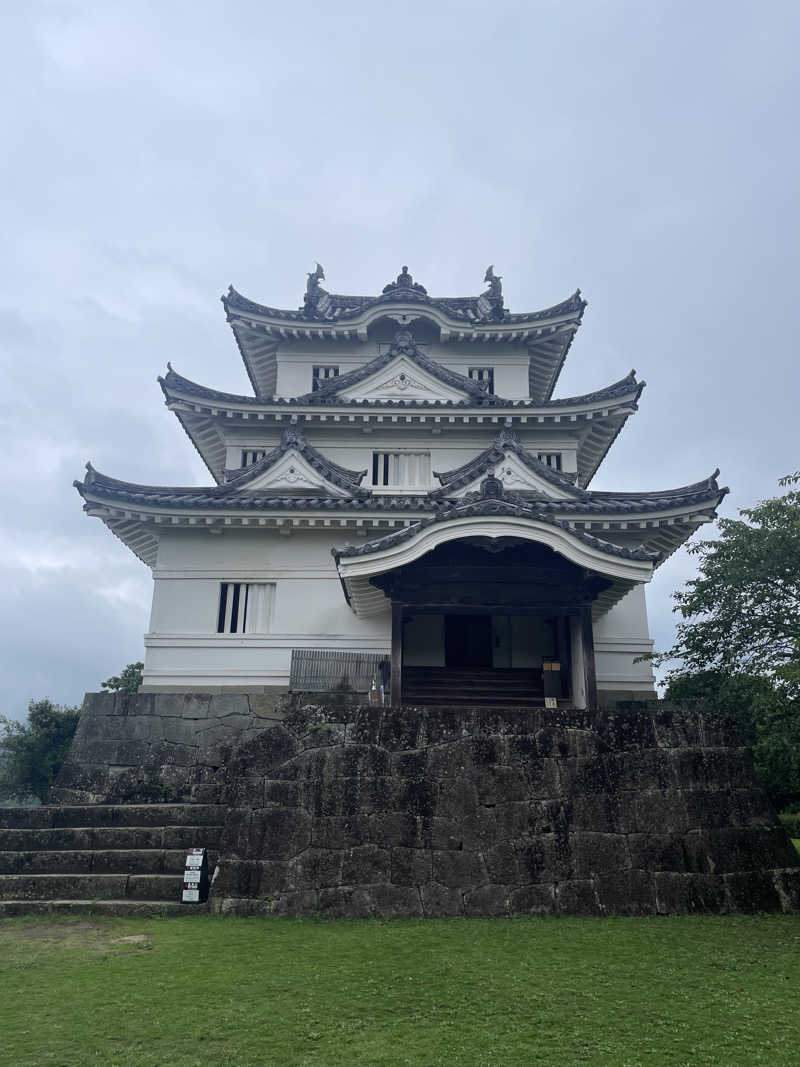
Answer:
[{"left": 221, "top": 268, "right": 586, "bottom": 327}]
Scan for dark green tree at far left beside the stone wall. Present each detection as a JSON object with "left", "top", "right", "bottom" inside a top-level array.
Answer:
[{"left": 0, "top": 698, "right": 80, "bottom": 801}]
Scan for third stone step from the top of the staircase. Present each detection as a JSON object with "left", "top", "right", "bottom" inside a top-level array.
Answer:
[{"left": 0, "top": 848, "right": 218, "bottom": 875}]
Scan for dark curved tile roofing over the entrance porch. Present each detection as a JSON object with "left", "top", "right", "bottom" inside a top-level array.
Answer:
[{"left": 332, "top": 476, "right": 657, "bottom": 562}]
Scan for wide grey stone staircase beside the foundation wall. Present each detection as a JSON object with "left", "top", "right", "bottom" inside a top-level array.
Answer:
[{"left": 0, "top": 803, "right": 226, "bottom": 918}]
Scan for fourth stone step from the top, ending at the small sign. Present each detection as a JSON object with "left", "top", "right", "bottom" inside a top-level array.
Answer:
[{"left": 0, "top": 874, "right": 183, "bottom": 902}]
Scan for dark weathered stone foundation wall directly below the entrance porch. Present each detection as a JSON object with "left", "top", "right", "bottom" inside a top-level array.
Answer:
[{"left": 213, "top": 704, "right": 800, "bottom": 917}]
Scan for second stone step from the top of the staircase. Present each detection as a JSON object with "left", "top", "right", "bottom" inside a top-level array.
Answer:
[{"left": 0, "top": 824, "right": 222, "bottom": 853}]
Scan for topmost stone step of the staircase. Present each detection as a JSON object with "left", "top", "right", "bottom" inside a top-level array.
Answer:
[{"left": 0, "top": 803, "right": 226, "bottom": 830}]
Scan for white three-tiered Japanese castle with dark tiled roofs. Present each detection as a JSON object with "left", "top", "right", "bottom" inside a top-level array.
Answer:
[{"left": 76, "top": 265, "right": 726, "bottom": 708}]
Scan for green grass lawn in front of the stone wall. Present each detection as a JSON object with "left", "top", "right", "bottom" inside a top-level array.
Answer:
[{"left": 0, "top": 915, "right": 800, "bottom": 1067}]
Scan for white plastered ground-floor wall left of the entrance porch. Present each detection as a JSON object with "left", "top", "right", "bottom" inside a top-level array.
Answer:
[{"left": 143, "top": 530, "right": 391, "bottom": 690}]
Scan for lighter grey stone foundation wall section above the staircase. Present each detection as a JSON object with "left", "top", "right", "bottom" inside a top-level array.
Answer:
[{"left": 48, "top": 692, "right": 283, "bottom": 803}]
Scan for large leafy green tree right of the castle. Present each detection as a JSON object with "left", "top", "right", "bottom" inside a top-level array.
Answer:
[{"left": 655, "top": 472, "right": 800, "bottom": 807}]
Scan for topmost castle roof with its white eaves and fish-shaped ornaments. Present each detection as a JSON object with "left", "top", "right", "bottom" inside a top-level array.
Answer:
[{"left": 221, "top": 264, "right": 586, "bottom": 403}]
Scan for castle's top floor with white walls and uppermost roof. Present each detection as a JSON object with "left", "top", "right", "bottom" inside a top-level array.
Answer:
[{"left": 222, "top": 265, "right": 586, "bottom": 402}]
